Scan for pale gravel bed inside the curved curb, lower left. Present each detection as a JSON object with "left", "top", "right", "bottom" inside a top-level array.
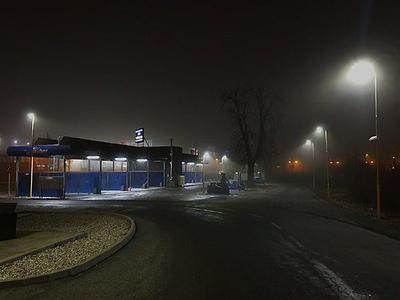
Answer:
[{"left": 0, "top": 213, "right": 131, "bottom": 280}]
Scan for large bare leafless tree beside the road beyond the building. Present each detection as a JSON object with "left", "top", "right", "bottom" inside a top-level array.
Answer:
[{"left": 223, "top": 88, "right": 282, "bottom": 186}]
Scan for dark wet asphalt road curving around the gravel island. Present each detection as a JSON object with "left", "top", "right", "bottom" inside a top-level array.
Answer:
[{"left": 0, "top": 185, "right": 400, "bottom": 299}]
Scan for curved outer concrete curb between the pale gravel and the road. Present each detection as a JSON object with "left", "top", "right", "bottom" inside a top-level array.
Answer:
[{"left": 0, "top": 213, "right": 136, "bottom": 288}]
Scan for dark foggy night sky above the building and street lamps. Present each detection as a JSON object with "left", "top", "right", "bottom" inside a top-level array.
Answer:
[{"left": 0, "top": 0, "right": 400, "bottom": 156}]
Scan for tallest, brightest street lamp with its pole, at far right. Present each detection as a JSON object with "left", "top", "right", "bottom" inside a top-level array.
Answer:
[{"left": 347, "top": 59, "right": 381, "bottom": 219}]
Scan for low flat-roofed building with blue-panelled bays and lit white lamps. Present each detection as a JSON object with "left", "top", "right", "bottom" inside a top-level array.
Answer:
[{"left": 7, "top": 136, "right": 203, "bottom": 198}]
